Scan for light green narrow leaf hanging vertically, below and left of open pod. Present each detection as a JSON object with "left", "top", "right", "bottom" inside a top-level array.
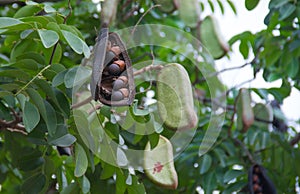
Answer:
[{"left": 74, "top": 143, "right": 88, "bottom": 177}]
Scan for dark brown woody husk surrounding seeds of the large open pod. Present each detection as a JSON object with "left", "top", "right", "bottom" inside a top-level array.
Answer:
[{"left": 91, "top": 28, "right": 135, "bottom": 106}]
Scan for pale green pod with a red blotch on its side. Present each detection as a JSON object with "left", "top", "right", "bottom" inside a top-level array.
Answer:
[{"left": 144, "top": 136, "right": 178, "bottom": 189}]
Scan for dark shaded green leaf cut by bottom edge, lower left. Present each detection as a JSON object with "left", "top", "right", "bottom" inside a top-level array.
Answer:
[{"left": 21, "top": 173, "right": 46, "bottom": 194}]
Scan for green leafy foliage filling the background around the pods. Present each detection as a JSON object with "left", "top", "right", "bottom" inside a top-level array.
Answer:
[{"left": 0, "top": 0, "right": 300, "bottom": 194}]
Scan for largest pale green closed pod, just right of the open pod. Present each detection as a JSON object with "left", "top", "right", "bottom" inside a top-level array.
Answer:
[{"left": 157, "top": 63, "right": 198, "bottom": 130}]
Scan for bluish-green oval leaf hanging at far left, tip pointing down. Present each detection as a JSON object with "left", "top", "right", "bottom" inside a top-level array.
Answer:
[{"left": 23, "top": 101, "right": 40, "bottom": 133}]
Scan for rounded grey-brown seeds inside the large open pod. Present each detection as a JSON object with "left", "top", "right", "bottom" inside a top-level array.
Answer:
[{"left": 100, "top": 41, "right": 129, "bottom": 101}]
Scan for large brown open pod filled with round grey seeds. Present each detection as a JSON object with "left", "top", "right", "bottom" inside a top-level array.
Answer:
[{"left": 91, "top": 28, "right": 135, "bottom": 106}]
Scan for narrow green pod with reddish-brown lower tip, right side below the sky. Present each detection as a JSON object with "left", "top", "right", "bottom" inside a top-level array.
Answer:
[{"left": 237, "top": 88, "right": 254, "bottom": 132}]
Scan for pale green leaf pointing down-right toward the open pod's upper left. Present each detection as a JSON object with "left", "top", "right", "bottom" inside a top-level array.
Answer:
[{"left": 61, "top": 30, "right": 90, "bottom": 58}]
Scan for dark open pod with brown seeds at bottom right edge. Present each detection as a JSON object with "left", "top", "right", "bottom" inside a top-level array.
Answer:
[{"left": 248, "top": 164, "right": 277, "bottom": 194}]
